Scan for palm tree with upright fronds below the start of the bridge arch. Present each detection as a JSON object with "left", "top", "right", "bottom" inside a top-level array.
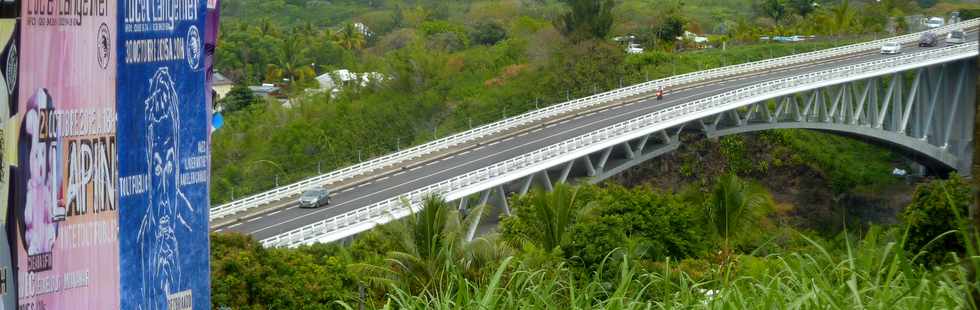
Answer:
[{"left": 706, "top": 174, "right": 772, "bottom": 257}]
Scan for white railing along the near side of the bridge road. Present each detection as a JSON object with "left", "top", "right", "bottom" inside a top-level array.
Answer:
[{"left": 261, "top": 42, "right": 977, "bottom": 247}]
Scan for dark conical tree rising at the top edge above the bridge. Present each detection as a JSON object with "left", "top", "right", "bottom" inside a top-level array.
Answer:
[{"left": 556, "top": 0, "right": 616, "bottom": 42}]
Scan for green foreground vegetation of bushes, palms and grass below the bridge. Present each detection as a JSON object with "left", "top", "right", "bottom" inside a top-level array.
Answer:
[{"left": 212, "top": 175, "right": 980, "bottom": 309}]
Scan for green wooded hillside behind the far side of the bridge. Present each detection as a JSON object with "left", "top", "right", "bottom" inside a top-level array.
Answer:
[{"left": 212, "top": 0, "right": 972, "bottom": 203}]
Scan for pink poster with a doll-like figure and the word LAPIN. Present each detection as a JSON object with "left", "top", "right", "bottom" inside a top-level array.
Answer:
[{"left": 13, "top": 0, "right": 120, "bottom": 309}]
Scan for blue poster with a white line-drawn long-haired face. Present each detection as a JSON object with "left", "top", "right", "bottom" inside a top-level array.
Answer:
[{"left": 116, "top": 0, "right": 211, "bottom": 310}]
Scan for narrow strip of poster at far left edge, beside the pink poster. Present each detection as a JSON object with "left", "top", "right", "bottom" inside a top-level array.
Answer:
[{"left": 0, "top": 0, "right": 20, "bottom": 310}]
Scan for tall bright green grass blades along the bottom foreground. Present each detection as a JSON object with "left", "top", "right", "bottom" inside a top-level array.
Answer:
[{"left": 354, "top": 229, "right": 977, "bottom": 309}]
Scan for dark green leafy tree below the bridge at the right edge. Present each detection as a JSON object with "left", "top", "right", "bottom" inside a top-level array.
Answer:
[{"left": 902, "top": 174, "right": 973, "bottom": 265}]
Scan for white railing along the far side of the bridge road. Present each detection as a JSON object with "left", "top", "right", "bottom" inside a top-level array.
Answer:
[{"left": 211, "top": 19, "right": 980, "bottom": 220}]
